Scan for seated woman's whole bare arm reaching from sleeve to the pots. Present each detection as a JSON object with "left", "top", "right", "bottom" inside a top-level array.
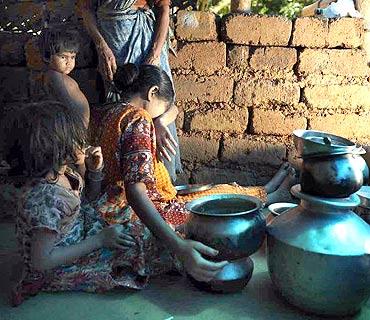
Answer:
[{"left": 126, "top": 182, "right": 227, "bottom": 281}]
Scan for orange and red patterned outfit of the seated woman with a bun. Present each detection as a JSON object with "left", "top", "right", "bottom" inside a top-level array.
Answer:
[{"left": 97, "top": 104, "right": 266, "bottom": 229}]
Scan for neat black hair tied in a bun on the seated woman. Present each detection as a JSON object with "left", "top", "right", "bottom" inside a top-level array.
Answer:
[{"left": 113, "top": 63, "right": 175, "bottom": 103}]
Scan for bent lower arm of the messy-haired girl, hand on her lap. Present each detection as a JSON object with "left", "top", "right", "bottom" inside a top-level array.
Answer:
[{"left": 31, "top": 225, "right": 135, "bottom": 271}]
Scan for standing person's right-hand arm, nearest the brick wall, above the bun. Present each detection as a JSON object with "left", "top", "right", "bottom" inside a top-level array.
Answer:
[{"left": 146, "top": 4, "right": 170, "bottom": 66}]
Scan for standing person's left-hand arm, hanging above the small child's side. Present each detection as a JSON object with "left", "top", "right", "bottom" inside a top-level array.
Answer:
[{"left": 77, "top": 0, "right": 117, "bottom": 81}]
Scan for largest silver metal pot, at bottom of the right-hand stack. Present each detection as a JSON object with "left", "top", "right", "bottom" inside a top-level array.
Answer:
[{"left": 267, "top": 186, "right": 370, "bottom": 316}]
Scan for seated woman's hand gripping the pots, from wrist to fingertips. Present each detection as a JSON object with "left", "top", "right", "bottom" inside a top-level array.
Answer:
[{"left": 177, "top": 240, "right": 228, "bottom": 282}]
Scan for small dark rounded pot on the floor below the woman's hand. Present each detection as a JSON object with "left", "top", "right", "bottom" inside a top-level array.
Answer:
[{"left": 188, "top": 257, "right": 254, "bottom": 293}]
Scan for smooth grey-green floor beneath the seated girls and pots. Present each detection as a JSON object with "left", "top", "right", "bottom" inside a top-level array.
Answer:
[{"left": 0, "top": 223, "right": 370, "bottom": 320}]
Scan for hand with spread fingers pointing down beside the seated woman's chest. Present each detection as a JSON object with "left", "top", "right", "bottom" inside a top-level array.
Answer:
[{"left": 154, "top": 118, "right": 178, "bottom": 161}]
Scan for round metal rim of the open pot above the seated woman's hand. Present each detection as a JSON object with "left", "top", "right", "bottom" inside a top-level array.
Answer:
[{"left": 185, "top": 193, "right": 262, "bottom": 217}]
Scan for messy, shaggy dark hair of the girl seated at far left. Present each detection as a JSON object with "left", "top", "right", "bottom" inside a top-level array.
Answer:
[{"left": 4, "top": 101, "right": 87, "bottom": 177}]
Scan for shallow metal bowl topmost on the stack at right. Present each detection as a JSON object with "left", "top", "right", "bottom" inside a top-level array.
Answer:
[{"left": 293, "top": 129, "right": 358, "bottom": 157}]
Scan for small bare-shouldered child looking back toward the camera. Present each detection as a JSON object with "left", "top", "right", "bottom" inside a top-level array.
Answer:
[{"left": 42, "top": 27, "right": 90, "bottom": 128}]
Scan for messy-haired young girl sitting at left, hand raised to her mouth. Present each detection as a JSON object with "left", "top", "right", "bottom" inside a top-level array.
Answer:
[{"left": 12, "top": 101, "right": 168, "bottom": 305}]
